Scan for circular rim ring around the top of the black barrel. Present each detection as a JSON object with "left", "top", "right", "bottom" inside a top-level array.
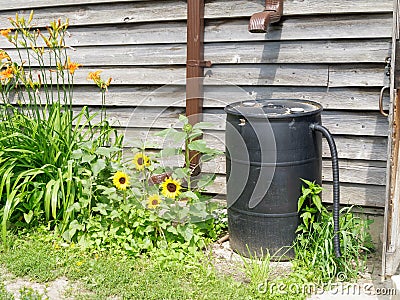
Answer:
[{"left": 224, "top": 98, "right": 323, "bottom": 119}]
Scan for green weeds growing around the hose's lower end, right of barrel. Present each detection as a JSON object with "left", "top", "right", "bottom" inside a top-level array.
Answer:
[{"left": 294, "top": 180, "right": 370, "bottom": 283}]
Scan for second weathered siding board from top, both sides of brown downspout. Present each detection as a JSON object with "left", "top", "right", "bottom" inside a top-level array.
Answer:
[{"left": 0, "top": 14, "right": 392, "bottom": 48}]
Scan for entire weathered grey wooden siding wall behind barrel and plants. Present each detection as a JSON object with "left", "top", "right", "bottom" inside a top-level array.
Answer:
[{"left": 0, "top": 0, "right": 392, "bottom": 207}]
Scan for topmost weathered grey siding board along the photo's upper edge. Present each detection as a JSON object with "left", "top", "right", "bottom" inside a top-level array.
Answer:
[{"left": 0, "top": 0, "right": 393, "bottom": 28}]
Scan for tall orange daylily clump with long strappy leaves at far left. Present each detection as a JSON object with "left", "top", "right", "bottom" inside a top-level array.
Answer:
[{"left": 0, "top": 13, "right": 121, "bottom": 243}]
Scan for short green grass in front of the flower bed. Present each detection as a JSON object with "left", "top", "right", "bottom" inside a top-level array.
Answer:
[{"left": 0, "top": 234, "right": 278, "bottom": 300}]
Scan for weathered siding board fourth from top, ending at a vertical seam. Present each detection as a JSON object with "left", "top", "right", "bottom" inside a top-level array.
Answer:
[{"left": 18, "top": 64, "right": 332, "bottom": 87}]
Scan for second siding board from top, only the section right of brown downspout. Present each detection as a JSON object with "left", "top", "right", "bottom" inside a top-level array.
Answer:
[{"left": 205, "top": 14, "right": 392, "bottom": 42}]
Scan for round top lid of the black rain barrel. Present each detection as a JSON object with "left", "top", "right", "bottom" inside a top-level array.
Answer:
[{"left": 225, "top": 99, "right": 322, "bottom": 118}]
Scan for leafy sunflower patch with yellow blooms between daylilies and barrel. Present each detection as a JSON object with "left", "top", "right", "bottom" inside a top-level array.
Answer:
[{"left": 63, "top": 117, "right": 226, "bottom": 256}]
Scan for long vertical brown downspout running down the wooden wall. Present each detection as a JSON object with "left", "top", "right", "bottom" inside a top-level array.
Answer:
[{"left": 186, "top": 0, "right": 211, "bottom": 175}]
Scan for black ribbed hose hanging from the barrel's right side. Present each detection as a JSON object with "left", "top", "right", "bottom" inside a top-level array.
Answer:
[{"left": 310, "top": 124, "right": 342, "bottom": 257}]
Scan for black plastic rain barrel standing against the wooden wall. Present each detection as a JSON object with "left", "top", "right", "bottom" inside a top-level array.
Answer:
[{"left": 225, "top": 99, "right": 322, "bottom": 257}]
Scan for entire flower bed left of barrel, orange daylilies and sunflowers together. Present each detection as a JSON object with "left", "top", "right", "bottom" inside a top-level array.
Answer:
[{"left": 0, "top": 13, "right": 226, "bottom": 255}]
